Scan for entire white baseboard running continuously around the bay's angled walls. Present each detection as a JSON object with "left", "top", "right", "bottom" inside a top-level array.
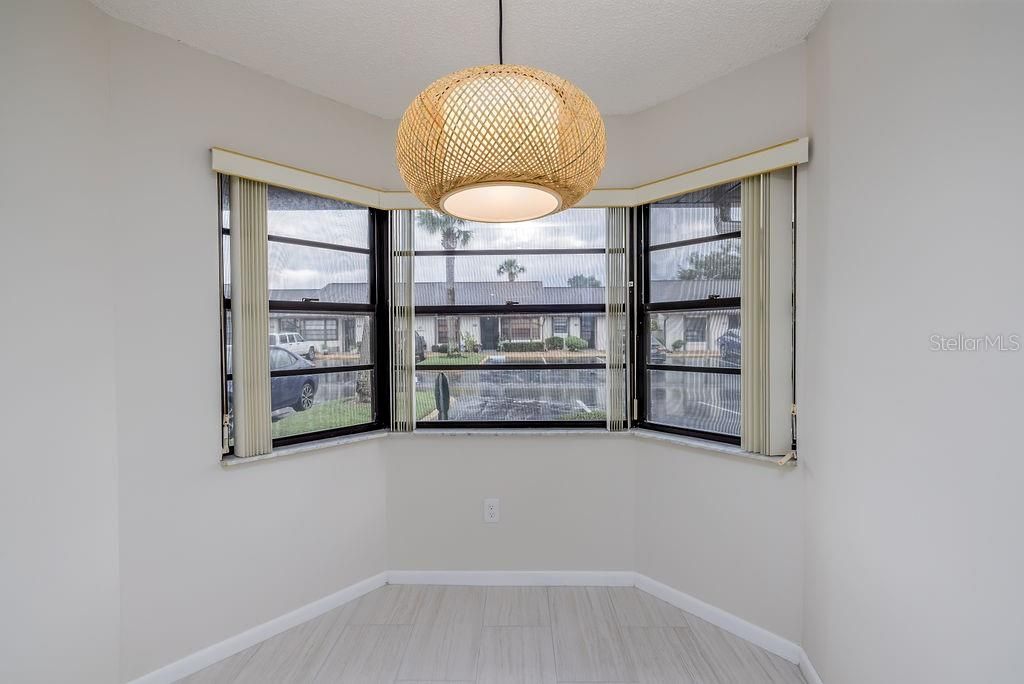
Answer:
[{"left": 130, "top": 570, "right": 822, "bottom": 684}]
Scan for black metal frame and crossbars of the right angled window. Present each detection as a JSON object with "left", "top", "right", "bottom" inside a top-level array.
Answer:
[{"left": 630, "top": 181, "right": 742, "bottom": 446}]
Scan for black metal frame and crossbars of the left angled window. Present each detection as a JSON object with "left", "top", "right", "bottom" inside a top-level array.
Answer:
[{"left": 217, "top": 174, "right": 391, "bottom": 458}]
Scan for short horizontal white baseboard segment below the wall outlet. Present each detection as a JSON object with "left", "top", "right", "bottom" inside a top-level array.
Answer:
[{"left": 387, "top": 570, "right": 636, "bottom": 587}]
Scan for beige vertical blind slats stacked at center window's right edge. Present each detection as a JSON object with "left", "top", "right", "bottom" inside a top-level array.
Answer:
[{"left": 605, "top": 207, "right": 630, "bottom": 431}]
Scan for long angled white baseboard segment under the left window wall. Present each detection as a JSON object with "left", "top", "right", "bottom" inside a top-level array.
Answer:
[{"left": 124, "top": 572, "right": 387, "bottom": 684}]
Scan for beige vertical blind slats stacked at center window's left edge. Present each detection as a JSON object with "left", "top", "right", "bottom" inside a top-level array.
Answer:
[{"left": 388, "top": 210, "right": 416, "bottom": 432}]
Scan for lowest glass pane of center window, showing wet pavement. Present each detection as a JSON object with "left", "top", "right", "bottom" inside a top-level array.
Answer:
[{"left": 416, "top": 364, "right": 606, "bottom": 422}]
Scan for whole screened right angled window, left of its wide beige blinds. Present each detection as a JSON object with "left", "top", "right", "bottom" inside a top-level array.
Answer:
[{"left": 636, "top": 182, "right": 742, "bottom": 443}]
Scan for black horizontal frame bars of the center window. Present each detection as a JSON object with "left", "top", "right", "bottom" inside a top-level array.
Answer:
[{"left": 413, "top": 210, "right": 608, "bottom": 431}]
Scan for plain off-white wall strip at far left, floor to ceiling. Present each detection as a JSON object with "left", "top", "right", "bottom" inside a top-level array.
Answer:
[{"left": 0, "top": 0, "right": 118, "bottom": 682}]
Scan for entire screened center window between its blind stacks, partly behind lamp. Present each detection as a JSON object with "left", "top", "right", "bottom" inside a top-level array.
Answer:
[{"left": 414, "top": 209, "right": 606, "bottom": 428}]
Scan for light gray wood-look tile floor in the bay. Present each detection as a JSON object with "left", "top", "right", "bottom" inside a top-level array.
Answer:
[{"left": 182, "top": 586, "right": 804, "bottom": 684}]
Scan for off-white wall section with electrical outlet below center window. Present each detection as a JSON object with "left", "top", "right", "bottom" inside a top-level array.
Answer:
[{"left": 385, "top": 432, "right": 635, "bottom": 570}]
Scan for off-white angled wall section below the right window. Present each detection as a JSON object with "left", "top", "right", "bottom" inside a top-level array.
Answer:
[{"left": 634, "top": 439, "right": 803, "bottom": 642}]
